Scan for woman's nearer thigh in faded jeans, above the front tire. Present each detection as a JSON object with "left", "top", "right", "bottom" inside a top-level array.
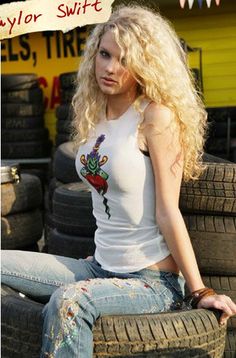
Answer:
[{"left": 52, "top": 277, "right": 182, "bottom": 323}]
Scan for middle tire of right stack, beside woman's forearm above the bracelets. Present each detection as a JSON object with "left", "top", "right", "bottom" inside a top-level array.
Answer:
[{"left": 183, "top": 214, "right": 236, "bottom": 276}]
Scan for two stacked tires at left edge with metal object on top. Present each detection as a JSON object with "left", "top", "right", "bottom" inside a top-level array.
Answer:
[{"left": 1, "top": 163, "right": 43, "bottom": 251}]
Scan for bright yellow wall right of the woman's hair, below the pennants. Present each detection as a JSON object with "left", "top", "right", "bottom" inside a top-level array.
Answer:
[{"left": 161, "top": 0, "right": 236, "bottom": 107}]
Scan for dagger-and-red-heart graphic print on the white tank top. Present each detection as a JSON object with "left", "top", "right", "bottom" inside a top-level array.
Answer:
[{"left": 80, "top": 134, "right": 111, "bottom": 219}]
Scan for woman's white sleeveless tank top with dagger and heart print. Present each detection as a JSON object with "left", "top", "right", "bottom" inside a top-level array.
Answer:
[{"left": 76, "top": 100, "right": 170, "bottom": 273}]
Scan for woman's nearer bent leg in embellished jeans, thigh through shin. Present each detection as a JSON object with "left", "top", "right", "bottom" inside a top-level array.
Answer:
[{"left": 42, "top": 270, "right": 182, "bottom": 357}]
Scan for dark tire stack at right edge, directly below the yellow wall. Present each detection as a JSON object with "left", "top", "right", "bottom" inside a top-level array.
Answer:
[{"left": 206, "top": 107, "right": 236, "bottom": 162}]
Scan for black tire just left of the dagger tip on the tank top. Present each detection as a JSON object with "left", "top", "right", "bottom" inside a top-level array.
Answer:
[{"left": 52, "top": 182, "right": 96, "bottom": 237}]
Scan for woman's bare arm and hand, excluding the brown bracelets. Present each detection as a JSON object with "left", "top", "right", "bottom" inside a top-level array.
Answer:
[{"left": 143, "top": 103, "right": 236, "bottom": 326}]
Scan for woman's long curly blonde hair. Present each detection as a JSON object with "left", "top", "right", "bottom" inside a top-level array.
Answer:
[{"left": 72, "top": 5, "right": 207, "bottom": 181}]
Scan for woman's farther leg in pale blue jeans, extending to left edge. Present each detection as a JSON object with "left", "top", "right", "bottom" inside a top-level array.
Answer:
[{"left": 1, "top": 250, "right": 102, "bottom": 302}]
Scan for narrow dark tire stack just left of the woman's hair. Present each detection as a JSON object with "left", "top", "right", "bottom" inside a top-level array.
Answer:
[{"left": 56, "top": 72, "right": 77, "bottom": 146}]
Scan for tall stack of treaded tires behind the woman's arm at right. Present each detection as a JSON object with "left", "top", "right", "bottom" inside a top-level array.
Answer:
[{"left": 180, "top": 153, "right": 236, "bottom": 358}]
